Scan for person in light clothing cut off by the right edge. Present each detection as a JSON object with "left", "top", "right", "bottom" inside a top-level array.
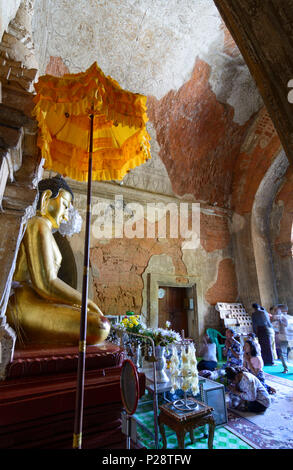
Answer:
[{"left": 272, "top": 304, "right": 293, "bottom": 374}]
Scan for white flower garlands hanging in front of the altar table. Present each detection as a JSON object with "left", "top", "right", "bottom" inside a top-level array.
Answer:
[{"left": 170, "top": 343, "right": 199, "bottom": 395}]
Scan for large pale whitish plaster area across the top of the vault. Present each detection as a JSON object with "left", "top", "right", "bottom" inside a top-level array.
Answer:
[{"left": 33, "top": 0, "right": 261, "bottom": 125}]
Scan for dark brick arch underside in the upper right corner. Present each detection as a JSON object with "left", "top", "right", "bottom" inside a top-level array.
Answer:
[{"left": 215, "top": 0, "right": 293, "bottom": 163}]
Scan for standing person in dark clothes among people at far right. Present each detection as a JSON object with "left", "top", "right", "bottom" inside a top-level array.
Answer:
[{"left": 251, "top": 303, "right": 275, "bottom": 365}]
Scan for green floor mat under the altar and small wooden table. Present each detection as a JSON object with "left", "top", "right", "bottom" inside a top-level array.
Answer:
[{"left": 135, "top": 404, "right": 252, "bottom": 449}]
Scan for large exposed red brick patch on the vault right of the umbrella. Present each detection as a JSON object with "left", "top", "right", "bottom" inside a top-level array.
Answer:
[{"left": 148, "top": 60, "right": 251, "bottom": 207}]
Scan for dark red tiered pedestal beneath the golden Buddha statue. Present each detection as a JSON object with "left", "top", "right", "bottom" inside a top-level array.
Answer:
[{"left": 0, "top": 342, "right": 145, "bottom": 449}]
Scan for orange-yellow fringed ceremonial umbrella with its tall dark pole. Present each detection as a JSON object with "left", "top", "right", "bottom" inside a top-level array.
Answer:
[{"left": 33, "top": 63, "right": 151, "bottom": 449}]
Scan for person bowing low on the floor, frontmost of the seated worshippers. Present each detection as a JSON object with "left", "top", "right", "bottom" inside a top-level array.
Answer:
[{"left": 226, "top": 366, "right": 271, "bottom": 413}]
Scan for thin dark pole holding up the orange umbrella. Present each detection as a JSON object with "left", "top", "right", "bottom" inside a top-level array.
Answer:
[{"left": 72, "top": 114, "right": 94, "bottom": 449}]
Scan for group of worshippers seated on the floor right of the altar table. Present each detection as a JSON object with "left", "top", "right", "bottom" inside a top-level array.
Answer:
[{"left": 197, "top": 328, "right": 276, "bottom": 413}]
